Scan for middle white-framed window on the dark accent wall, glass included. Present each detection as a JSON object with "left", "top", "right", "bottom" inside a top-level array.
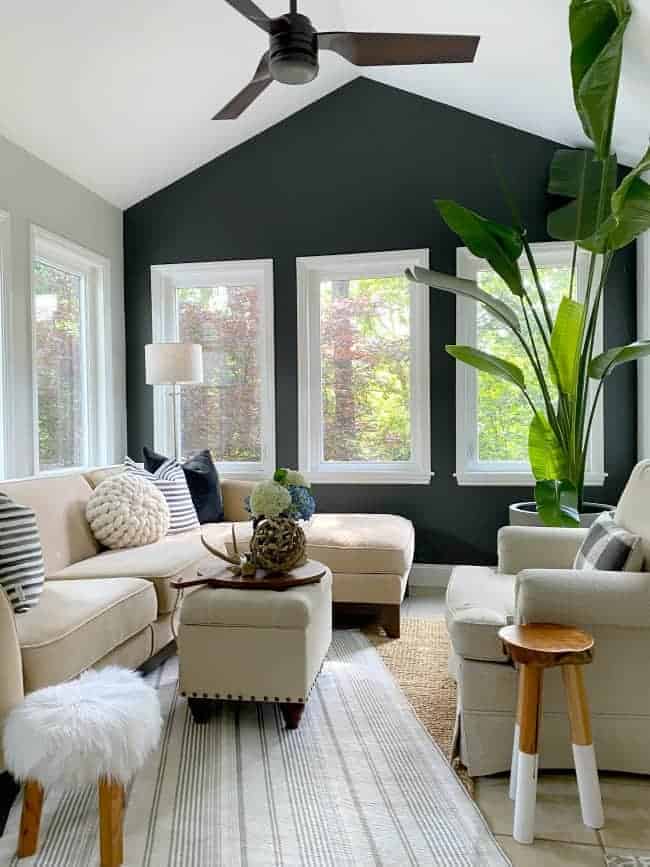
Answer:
[{"left": 297, "top": 250, "right": 431, "bottom": 484}]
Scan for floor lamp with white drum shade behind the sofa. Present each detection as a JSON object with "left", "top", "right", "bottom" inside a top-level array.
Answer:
[{"left": 144, "top": 343, "right": 203, "bottom": 460}]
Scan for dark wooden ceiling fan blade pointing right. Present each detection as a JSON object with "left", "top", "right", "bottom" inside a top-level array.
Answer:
[{"left": 318, "top": 33, "right": 480, "bottom": 66}]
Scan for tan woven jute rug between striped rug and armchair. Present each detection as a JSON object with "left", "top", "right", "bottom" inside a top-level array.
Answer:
[{"left": 364, "top": 618, "right": 474, "bottom": 796}]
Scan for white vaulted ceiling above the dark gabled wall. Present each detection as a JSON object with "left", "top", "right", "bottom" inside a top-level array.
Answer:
[{"left": 0, "top": 0, "right": 650, "bottom": 207}]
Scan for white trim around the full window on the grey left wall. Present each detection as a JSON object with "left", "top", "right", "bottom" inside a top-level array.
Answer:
[{"left": 29, "top": 225, "right": 110, "bottom": 476}]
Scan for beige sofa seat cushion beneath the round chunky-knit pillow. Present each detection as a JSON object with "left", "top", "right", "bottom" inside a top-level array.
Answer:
[{"left": 48, "top": 523, "right": 237, "bottom": 614}]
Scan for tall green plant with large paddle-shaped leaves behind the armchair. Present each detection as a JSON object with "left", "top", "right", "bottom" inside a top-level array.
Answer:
[{"left": 407, "top": 0, "right": 650, "bottom": 526}]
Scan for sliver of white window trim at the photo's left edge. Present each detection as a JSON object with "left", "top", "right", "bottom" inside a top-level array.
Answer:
[{"left": 0, "top": 211, "right": 13, "bottom": 479}]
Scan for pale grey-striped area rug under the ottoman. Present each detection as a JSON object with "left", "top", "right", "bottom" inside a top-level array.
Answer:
[{"left": 0, "top": 631, "right": 509, "bottom": 867}]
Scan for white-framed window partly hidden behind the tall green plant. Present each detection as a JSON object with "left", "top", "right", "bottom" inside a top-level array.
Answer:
[{"left": 456, "top": 242, "right": 605, "bottom": 485}]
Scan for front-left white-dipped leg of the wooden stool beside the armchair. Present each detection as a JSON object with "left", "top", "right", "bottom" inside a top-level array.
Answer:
[{"left": 512, "top": 665, "right": 544, "bottom": 843}]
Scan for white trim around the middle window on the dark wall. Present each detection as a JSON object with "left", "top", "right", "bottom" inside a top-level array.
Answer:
[{"left": 296, "top": 250, "right": 432, "bottom": 485}]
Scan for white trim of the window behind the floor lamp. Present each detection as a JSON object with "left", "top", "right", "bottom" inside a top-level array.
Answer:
[{"left": 151, "top": 259, "right": 276, "bottom": 481}]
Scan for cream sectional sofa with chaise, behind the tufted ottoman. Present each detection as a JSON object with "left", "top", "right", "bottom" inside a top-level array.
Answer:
[{"left": 0, "top": 466, "right": 414, "bottom": 769}]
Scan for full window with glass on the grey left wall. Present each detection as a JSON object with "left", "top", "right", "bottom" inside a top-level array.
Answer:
[{"left": 31, "top": 227, "right": 109, "bottom": 473}]
